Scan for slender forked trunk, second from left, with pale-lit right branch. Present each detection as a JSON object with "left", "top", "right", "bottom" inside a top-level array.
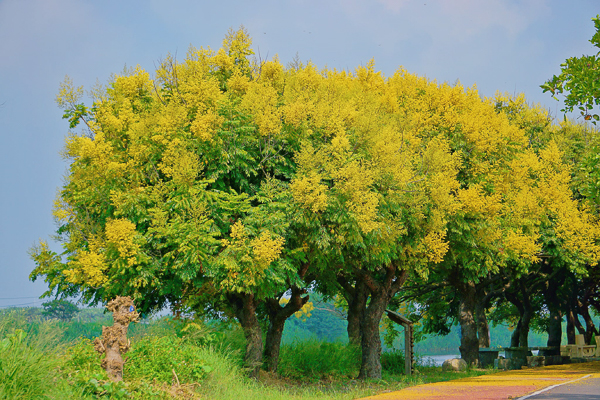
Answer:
[{"left": 265, "top": 288, "right": 308, "bottom": 372}]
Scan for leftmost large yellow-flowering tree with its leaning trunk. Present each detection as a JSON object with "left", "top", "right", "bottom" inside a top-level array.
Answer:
[{"left": 31, "top": 29, "right": 306, "bottom": 374}]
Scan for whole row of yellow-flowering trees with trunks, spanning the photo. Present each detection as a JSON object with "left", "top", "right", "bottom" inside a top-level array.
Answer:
[{"left": 31, "top": 21, "right": 600, "bottom": 378}]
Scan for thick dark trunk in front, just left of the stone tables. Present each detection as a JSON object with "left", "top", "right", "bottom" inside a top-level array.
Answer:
[{"left": 457, "top": 283, "right": 479, "bottom": 365}]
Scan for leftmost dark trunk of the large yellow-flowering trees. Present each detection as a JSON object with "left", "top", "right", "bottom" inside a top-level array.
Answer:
[{"left": 231, "top": 293, "right": 263, "bottom": 379}]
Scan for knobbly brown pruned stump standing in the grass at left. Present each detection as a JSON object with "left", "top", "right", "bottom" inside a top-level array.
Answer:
[{"left": 94, "top": 296, "right": 139, "bottom": 382}]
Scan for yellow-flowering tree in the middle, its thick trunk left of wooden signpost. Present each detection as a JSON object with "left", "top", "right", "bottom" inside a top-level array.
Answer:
[{"left": 284, "top": 63, "right": 460, "bottom": 378}]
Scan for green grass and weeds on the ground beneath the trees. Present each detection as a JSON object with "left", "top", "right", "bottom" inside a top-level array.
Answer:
[{"left": 0, "top": 311, "right": 489, "bottom": 400}]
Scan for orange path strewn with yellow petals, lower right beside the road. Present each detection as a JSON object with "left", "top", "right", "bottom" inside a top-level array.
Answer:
[{"left": 364, "top": 361, "right": 600, "bottom": 400}]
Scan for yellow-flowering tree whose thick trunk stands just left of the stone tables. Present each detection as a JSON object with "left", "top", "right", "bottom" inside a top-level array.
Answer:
[{"left": 372, "top": 77, "right": 595, "bottom": 363}]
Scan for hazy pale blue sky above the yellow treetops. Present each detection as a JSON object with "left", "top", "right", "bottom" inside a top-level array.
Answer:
[{"left": 0, "top": 0, "right": 600, "bottom": 308}]
